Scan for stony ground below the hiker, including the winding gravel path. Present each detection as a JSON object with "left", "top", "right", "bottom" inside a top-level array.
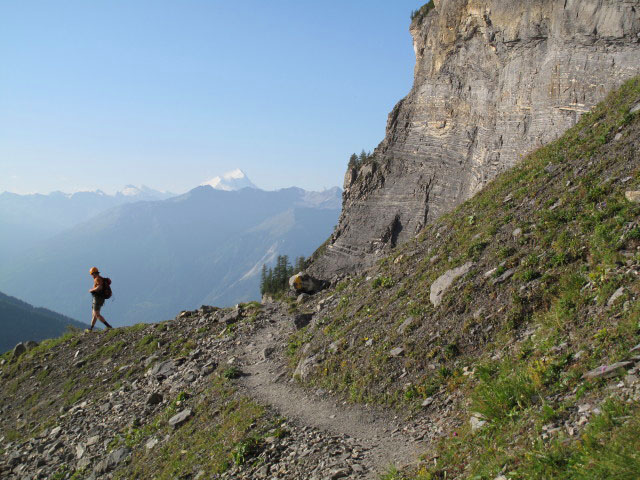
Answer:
[{"left": 0, "top": 303, "right": 430, "bottom": 480}]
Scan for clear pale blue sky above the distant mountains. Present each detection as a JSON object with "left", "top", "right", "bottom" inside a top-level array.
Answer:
[{"left": 0, "top": 0, "right": 424, "bottom": 193}]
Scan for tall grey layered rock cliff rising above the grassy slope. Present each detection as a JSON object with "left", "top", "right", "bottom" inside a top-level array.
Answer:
[{"left": 311, "top": 0, "right": 640, "bottom": 277}]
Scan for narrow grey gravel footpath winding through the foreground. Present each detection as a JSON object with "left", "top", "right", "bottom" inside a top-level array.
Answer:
[{"left": 235, "top": 319, "right": 421, "bottom": 478}]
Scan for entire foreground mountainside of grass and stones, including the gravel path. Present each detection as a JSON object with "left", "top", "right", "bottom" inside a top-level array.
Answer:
[{"left": 0, "top": 77, "right": 640, "bottom": 480}]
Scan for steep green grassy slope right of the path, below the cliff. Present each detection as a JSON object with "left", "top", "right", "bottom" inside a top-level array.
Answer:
[{"left": 290, "top": 78, "right": 640, "bottom": 479}]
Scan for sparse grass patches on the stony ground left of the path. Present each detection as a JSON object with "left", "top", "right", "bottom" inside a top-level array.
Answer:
[{"left": 0, "top": 303, "right": 283, "bottom": 479}]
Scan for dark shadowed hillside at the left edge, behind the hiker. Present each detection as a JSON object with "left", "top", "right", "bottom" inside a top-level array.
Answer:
[{"left": 0, "top": 292, "right": 89, "bottom": 352}]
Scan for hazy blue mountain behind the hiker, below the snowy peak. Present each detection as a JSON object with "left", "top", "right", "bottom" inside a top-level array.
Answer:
[{"left": 0, "top": 186, "right": 340, "bottom": 326}]
